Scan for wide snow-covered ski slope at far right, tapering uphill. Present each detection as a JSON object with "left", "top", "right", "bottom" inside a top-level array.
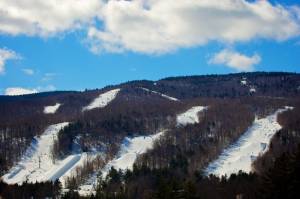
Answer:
[{"left": 205, "top": 107, "right": 291, "bottom": 177}]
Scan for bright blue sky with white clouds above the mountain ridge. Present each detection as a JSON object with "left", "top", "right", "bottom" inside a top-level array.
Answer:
[{"left": 0, "top": 0, "right": 300, "bottom": 94}]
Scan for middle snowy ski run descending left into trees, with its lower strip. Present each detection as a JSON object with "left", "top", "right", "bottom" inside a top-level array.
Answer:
[{"left": 79, "top": 131, "right": 165, "bottom": 195}]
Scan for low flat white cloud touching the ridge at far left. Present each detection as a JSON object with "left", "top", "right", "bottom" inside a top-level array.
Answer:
[{"left": 4, "top": 85, "right": 56, "bottom": 96}]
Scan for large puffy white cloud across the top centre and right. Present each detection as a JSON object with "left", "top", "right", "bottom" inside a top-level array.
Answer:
[{"left": 88, "top": 0, "right": 300, "bottom": 54}]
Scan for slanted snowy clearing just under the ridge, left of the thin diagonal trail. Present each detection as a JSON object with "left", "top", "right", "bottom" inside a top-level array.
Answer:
[{"left": 82, "top": 88, "right": 121, "bottom": 111}]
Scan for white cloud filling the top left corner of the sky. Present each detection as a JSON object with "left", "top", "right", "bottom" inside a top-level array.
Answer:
[{"left": 0, "top": 0, "right": 101, "bottom": 37}]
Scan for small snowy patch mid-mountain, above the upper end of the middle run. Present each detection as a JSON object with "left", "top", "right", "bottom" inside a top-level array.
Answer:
[{"left": 176, "top": 106, "right": 207, "bottom": 126}]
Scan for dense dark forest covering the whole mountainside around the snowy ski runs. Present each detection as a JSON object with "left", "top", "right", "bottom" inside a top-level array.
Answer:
[{"left": 0, "top": 73, "right": 300, "bottom": 199}]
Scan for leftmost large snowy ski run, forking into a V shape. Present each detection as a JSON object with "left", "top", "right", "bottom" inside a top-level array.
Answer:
[{"left": 3, "top": 122, "right": 71, "bottom": 184}]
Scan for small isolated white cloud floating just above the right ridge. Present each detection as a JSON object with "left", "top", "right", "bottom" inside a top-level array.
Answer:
[{"left": 208, "top": 49, "right": 261, "bottom": 71}]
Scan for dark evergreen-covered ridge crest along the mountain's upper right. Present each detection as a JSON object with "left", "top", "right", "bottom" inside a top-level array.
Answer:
[{"left": 154, "top": 72, "right": 300, "bottom": 99}]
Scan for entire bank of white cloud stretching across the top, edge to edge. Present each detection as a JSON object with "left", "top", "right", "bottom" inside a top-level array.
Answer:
[{"left": 0, "top": 0, "right": 300, "bottom": 54}]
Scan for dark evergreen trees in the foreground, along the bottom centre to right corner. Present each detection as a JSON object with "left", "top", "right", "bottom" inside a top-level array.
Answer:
[{"left": 87, "top": 145, "right": 300, "bottom": 199}]
